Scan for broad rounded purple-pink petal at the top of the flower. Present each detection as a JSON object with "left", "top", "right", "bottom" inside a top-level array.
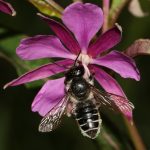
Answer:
[{"left": 62, "top": 2, "right": 103, "bottom": 53}]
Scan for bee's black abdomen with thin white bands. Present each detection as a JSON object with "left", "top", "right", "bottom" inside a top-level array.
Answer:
[{"left": 74, "top": 100, "right": 101, "bottom": 138}]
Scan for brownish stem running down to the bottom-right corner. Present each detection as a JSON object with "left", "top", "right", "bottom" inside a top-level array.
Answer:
[{"left": 123, "top": 116, "right": 146, "bottom": 150}]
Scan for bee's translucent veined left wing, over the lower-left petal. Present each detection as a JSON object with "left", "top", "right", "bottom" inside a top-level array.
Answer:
[{"left": 39, "top": 96, "right": 69, "bottom": 132}]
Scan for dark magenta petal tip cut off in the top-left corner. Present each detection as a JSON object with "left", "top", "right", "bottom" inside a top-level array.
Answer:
[{"left": 0, "top": 0, "right": 16, "bottom": 16}]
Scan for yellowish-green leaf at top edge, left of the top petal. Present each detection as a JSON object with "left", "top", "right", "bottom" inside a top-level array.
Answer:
[{"left": 29, "top": 0, "right": 61, "bottom": 18}]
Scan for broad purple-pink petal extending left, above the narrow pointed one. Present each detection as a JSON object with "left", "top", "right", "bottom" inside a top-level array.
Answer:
[{"left": 16, "top": 35, "right": 76, "bottom": 60}]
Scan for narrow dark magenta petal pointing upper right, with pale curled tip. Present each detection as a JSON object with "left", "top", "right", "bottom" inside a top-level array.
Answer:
[{"left": 88, "top": 25, "right": 122, "bottom": 57}]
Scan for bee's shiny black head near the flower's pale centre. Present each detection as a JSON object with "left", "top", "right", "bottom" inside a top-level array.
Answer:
[{"left": 66, "top": 65, "right": 85, "bottom": 80}]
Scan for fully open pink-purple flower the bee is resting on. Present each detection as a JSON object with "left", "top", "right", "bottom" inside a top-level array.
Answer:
[{"left": 5, "top": 3, "right": 140, "bottom": 118}]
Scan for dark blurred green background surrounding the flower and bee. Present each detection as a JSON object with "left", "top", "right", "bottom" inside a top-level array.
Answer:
[{"left": 0, "top": 0, "right": 150, "bottom": 150}]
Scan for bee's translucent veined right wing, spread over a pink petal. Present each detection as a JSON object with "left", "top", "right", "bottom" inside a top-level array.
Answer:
[{"left": 91, "top": 86, "right": 134, "bottom": 115}]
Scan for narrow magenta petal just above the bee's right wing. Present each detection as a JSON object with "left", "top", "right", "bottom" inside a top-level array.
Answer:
[{"left": 89, "top": 65, "right": 126, "bottom": 97}]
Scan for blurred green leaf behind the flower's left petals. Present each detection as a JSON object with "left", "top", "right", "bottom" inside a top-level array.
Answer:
[{"left": 0, "top": 31, "right": 49, "bottom": 87}]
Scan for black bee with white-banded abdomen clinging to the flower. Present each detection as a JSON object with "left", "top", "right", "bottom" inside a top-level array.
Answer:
[{"left": 39, "top": 61, "right": 134, "bottom": 139}]
